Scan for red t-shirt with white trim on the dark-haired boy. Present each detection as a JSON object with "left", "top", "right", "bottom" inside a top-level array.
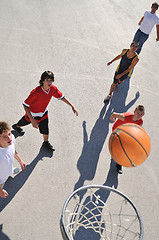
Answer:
[{"left": 23, "top": 85, "right": 64, "bottom": 117}]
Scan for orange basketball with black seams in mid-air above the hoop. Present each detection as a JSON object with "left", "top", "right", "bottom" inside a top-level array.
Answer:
[{"left": 109, "top": 123, "right": 151, "bottom": 167}]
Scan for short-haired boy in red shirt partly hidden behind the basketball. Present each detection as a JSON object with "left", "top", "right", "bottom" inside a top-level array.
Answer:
[{"left": 110, "top": 105, "right": 145, "bottom": 174}]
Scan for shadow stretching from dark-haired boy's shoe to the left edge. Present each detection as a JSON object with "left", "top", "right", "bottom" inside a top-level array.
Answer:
[{"left": 0, "top": 147, "right": 53, "bottom": 212}]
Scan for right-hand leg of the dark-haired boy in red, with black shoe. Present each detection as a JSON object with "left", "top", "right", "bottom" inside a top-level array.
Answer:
[{"left": 39, "top": 118, "right": 55, "bottom": 151}]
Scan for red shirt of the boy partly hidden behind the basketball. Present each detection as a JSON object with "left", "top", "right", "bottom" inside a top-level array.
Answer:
[{"left": 112, "top": 112, "right": 143, "bottom": 131}]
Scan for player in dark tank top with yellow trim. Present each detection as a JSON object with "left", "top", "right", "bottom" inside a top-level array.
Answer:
[{"left": 104, "top": 42, "right": 139, "bottom": 103}]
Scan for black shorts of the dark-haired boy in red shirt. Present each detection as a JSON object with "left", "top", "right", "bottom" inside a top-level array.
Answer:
[{"left": 17, "top": 113, "right": 49, "bottom": 135}]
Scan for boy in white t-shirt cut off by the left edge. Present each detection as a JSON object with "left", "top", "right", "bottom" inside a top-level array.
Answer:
[{"left": 0, "top": 122, "right": 26, "bottom": 198}]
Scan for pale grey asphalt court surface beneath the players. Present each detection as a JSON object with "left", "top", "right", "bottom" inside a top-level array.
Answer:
[{"left": 0, "top": 0, "right": 159, "bottom": 240}]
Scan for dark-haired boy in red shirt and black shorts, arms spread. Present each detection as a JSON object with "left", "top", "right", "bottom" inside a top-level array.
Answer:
[{"left": 12, "top": 71, "right": 78, "bottom": 151}]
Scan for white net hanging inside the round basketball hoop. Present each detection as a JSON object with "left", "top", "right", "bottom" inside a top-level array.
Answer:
[{"left": 60, "top": 187, "right": 142, "bottom": 240}]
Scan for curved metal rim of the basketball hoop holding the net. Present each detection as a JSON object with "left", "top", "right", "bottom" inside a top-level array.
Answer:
[{"left": 60, "top": 184, "right": 144, "bottom": 240}]
